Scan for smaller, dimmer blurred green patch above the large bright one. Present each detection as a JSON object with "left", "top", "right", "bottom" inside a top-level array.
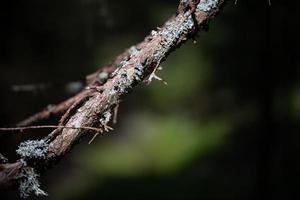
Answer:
[{"left": 147, "top": 42, "right": 212, "bottom": 108}]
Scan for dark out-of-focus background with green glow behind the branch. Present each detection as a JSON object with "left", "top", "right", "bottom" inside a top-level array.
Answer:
[{"left": 0, "top": 0, "right": 300, "bottom": 200}]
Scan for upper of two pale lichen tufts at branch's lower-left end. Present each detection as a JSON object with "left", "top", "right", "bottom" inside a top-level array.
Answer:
[{"left": 16, "top": 140, "right": 49, "bottom": 159}]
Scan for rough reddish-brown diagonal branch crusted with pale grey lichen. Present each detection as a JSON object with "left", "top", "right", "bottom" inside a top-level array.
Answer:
[{"left": 0, "top": 0, "right": 226, "bottom": 195}]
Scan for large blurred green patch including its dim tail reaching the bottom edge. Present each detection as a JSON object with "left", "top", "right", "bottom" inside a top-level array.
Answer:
[{"left": 52, "top": 113, "right": 232, "bottom": 199}]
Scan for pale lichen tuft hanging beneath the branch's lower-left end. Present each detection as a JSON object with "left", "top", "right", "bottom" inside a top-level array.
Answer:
[{"left": 17, "top": 164, "right": 48, "bottom": 198}]
